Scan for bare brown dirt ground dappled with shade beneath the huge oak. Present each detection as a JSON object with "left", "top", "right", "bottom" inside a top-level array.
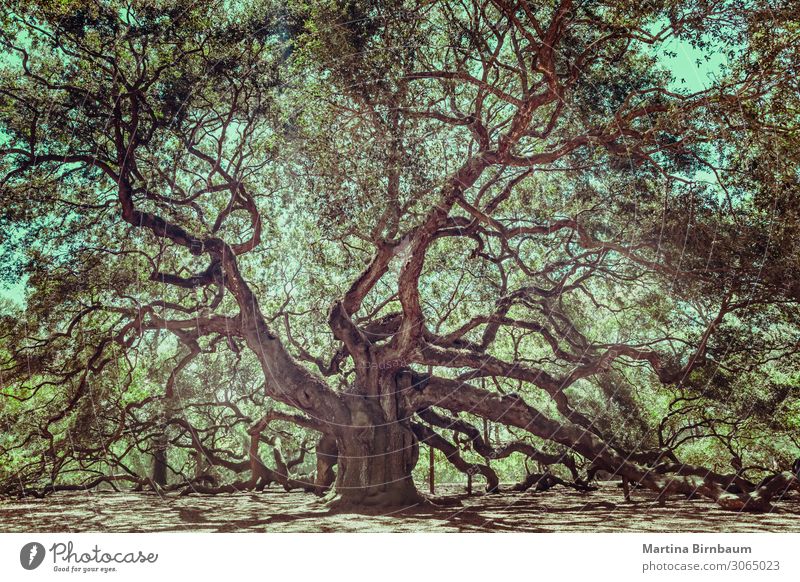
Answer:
[{"left": 0, "top": 484, "right": 800, "bottom": 532}]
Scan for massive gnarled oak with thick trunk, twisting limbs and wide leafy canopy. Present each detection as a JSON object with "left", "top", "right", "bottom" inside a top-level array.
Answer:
[{"left": 0, "top": 0, "right": 800, "bottom": 510}]
